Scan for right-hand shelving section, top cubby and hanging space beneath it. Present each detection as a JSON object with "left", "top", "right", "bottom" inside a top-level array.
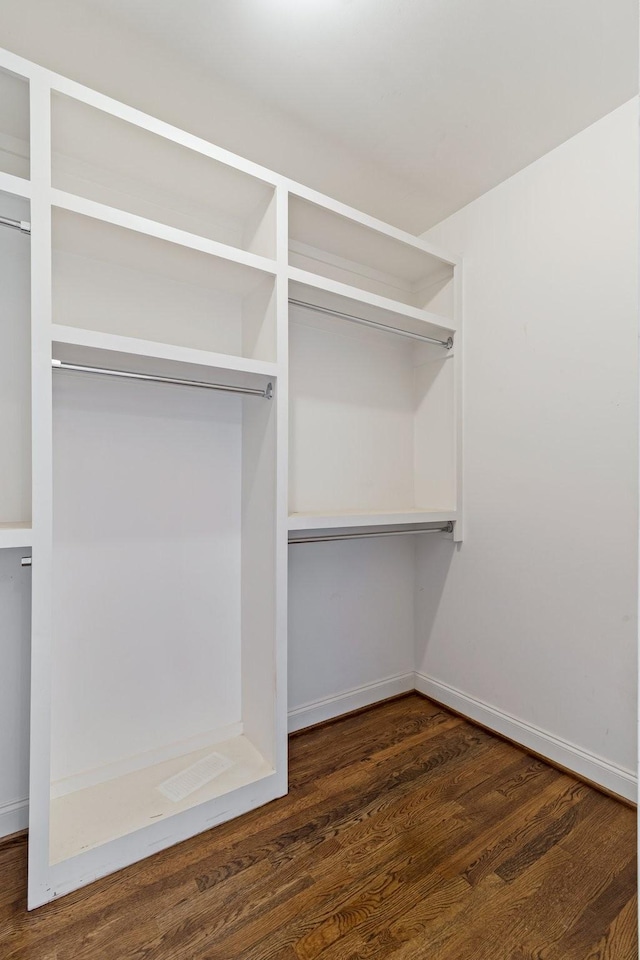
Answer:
[{"left": 289, "top": 196, "right": 462, "bottom": 539}]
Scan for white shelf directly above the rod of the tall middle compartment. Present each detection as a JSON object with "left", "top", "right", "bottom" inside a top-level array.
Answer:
[{"left": 51, "top": 324, "right": 278, "bottom": 386}]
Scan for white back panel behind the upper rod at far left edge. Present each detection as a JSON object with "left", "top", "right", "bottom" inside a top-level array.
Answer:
[{"left": 0, "top": 193, "right": 31, "bottom": 523}]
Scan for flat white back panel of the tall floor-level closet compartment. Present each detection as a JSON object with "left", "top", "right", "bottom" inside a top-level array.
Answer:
[{"left": 52, "top": 372, "right": 241, "bottom": 780}]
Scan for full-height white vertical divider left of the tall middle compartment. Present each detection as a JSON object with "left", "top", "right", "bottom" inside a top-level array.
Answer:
[{"left": 28, "top": 73, "right": 55, "bottom": 909}]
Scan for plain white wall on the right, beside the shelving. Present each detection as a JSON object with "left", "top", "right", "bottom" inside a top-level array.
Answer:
[{"left": 417, "top": 101, "right": 638, "bottom": 790}]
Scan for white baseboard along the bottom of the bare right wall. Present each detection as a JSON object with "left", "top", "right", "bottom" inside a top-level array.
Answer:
[{"left": 415, "top": 673, "right": 638, "bottom": 803}]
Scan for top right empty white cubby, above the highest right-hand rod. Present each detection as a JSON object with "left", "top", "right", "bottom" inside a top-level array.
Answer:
[{"left": 289, "top": 195, "right": 454, "bottom": 320}]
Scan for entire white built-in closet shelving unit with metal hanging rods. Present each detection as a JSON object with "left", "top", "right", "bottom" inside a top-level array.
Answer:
[{"left": 0, "top": 43, "right": 462, "bottom": 907}]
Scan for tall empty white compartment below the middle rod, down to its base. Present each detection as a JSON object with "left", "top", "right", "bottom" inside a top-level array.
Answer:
[{"left": 49, "top": 365, "right": 277, "bottom": 869}]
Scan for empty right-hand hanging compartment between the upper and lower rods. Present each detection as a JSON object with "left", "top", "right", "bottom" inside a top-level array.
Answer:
[{"left": 289, "top": 286, "right": 457, "bottom": 529}]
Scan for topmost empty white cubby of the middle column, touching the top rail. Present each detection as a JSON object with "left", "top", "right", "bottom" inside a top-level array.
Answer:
[{"left": 51, "top": 93, "right": 275, "bottom": 258}]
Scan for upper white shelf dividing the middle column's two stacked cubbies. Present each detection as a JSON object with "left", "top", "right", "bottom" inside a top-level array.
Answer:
[{"left": 51, "top": 189, "right": 276, "bottom": 274}]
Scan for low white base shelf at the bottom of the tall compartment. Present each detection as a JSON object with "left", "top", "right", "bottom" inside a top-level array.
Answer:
[{"left": 50, "top": 734, "right": 274, "bottom": 864}]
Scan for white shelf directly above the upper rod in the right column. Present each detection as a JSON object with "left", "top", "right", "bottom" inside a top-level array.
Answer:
[{"left": 289, "top": 267, "right": 455, "bottom": 340}]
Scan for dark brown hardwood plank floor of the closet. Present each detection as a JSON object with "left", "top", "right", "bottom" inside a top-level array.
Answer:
[{"left": 0, "top": 695, "right": 638, "bottom": 960}]
